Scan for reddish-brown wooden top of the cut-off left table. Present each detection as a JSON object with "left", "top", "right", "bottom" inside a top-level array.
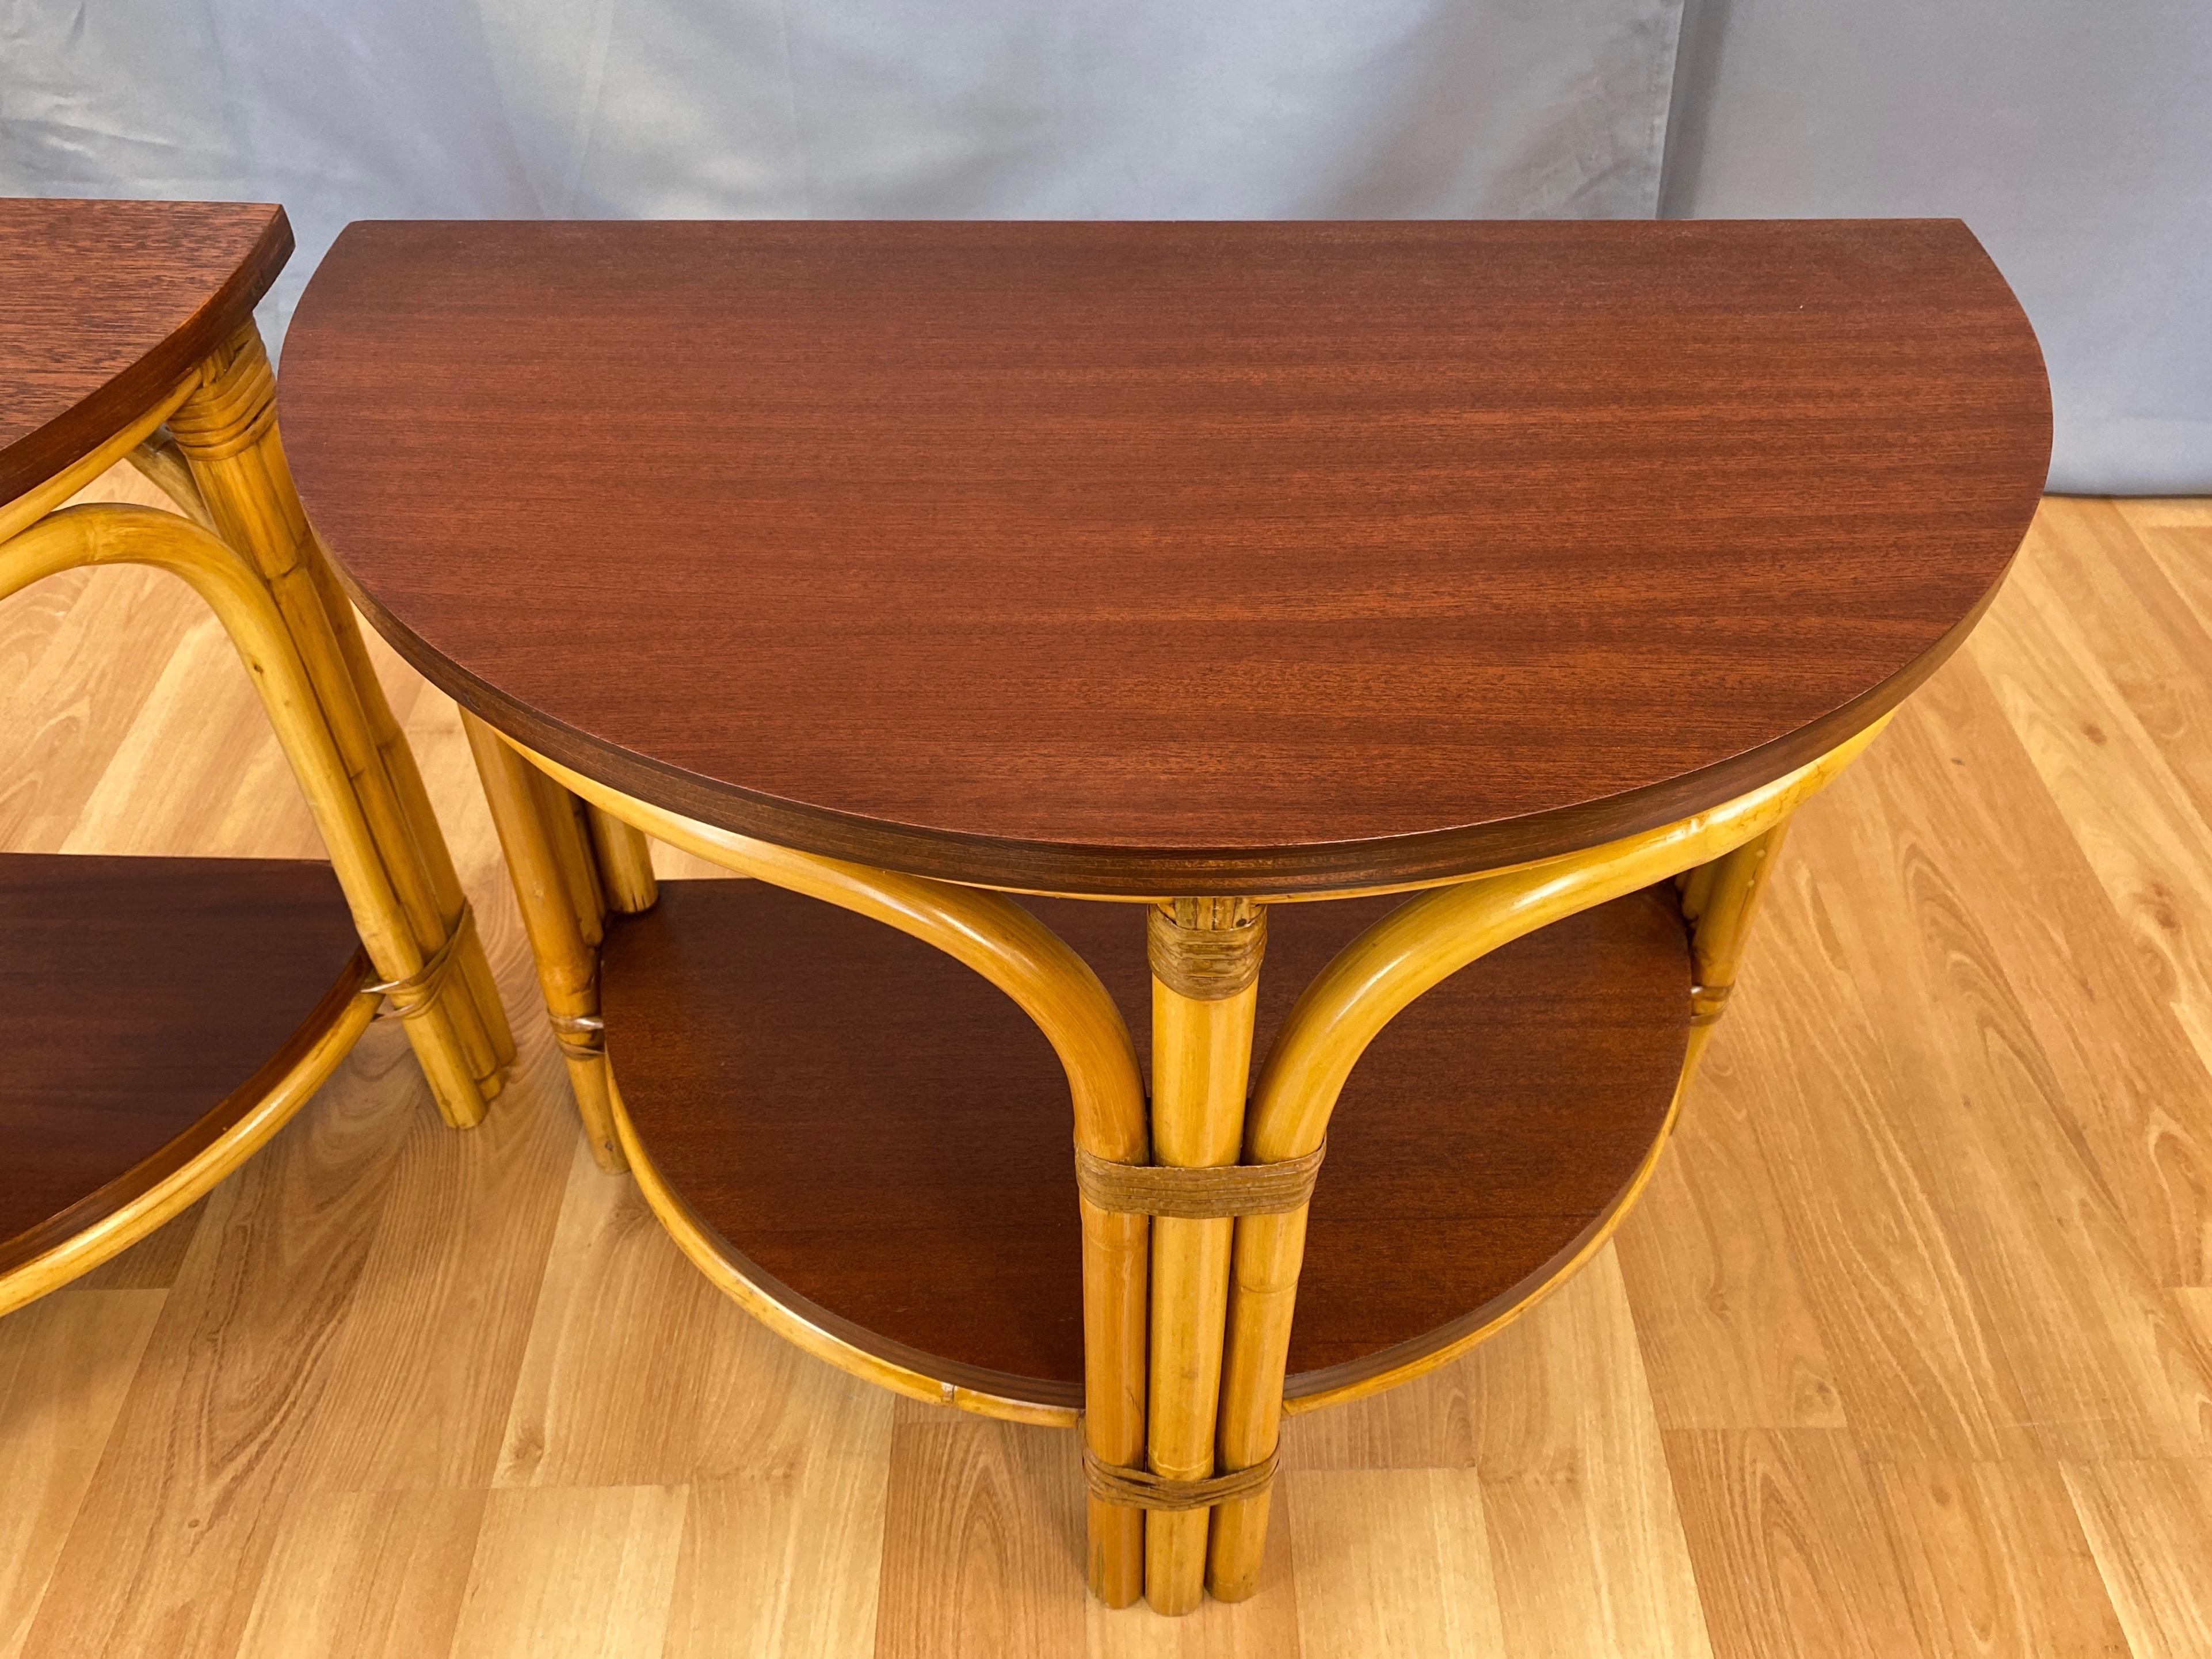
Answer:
[{"left": 0, "top": 199, "right": 292, "bottom": 502}]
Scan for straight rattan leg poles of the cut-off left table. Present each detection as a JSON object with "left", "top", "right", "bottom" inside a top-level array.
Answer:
[{"left": 157, "top": 323, "right": 513, "bottom": 1126}]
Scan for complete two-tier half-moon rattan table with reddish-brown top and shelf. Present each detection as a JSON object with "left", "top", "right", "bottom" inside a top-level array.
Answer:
[{"left": 281, "top": 221, "right": 2050, "bottom": 1612}]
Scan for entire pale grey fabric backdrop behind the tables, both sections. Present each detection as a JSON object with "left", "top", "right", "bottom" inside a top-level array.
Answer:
[{"left": 0, "top": 0, "right": 2212, "bottom": 491}]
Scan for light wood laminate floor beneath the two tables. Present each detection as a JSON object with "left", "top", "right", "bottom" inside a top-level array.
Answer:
[{"left": 0, "top": 473, "right": 2212, "bottom": 1659}]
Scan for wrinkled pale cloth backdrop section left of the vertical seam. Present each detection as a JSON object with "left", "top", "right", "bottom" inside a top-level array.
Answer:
[{"left": 0, "top": 0, "right": 1681, "bottom": 330}]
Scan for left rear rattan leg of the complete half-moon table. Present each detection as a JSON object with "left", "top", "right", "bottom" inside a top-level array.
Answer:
[{"left": 460, "top": 710, "right": 628, "bottom": 1170}]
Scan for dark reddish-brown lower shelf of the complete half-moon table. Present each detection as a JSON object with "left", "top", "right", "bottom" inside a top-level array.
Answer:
[{"left": 602, "top": 880, "right": 1690, "bottom": 1402}]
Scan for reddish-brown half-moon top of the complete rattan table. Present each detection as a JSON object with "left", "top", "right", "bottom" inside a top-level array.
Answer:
[{"left": 279, "top": 219, "right": 2050, "bottom": 896}]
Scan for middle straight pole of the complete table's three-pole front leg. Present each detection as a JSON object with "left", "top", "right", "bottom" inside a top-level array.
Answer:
[{"left": 1143, "top": 898, "right": 1268, "bottom": 1612}]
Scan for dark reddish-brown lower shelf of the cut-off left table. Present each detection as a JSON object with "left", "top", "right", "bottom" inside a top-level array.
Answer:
[{"left": 0, "top": 854, "right": 369, "bottom": 1272}]
